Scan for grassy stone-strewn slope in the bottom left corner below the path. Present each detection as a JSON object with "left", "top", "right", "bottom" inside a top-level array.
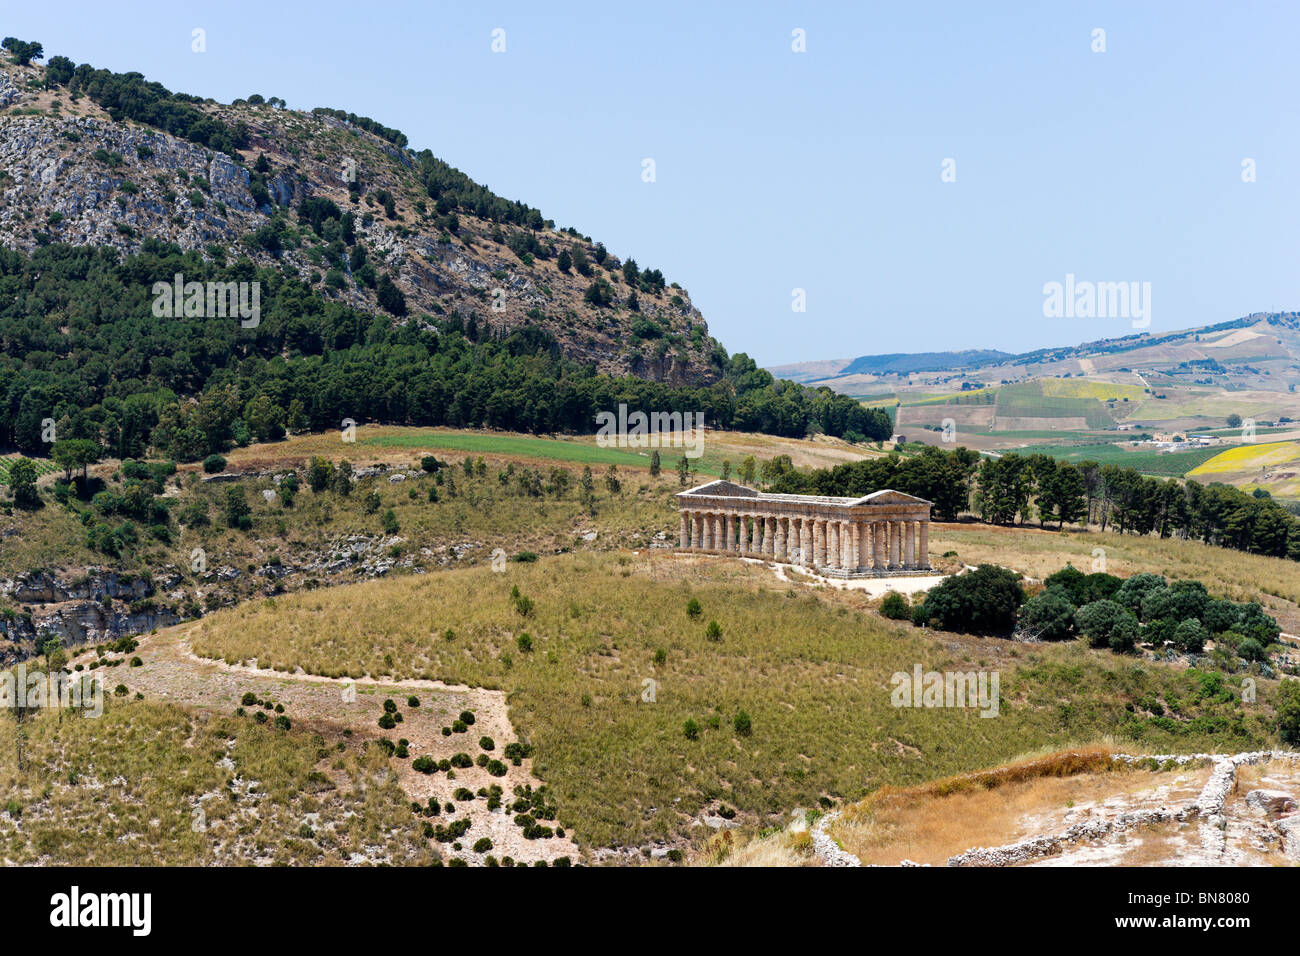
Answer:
[{"left": 0, "top": 697, "right": 433, "bottom": 866}]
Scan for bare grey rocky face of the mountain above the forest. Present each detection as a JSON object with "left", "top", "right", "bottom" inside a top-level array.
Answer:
[{"left": 0, "top": 65, "right": 720, "bottom": 385}]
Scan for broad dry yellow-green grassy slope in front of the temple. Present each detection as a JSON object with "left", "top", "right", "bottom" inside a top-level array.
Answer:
[{"left": 192, "top": 555, "right": 1289, "bottom": 845}]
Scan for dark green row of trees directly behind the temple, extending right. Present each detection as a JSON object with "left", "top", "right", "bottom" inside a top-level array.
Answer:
[{"left": 772, "top": 447, "right": 1300, "bottom": 559}]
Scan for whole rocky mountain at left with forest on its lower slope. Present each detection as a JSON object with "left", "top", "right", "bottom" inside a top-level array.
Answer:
[{"left": 0, "top": 38, "right": 891, "bottom": 460}]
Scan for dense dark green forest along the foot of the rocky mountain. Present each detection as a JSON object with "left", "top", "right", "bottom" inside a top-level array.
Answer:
[{"left": 0, "top": 239, "right": 889, "bottom": 460}]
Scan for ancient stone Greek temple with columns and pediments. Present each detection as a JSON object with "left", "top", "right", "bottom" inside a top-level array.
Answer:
[{"left": 676, "top": 481, "right": 931, "bottom": 578}]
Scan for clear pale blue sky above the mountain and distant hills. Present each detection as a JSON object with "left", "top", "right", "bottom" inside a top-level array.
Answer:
[{"left": 10, "top": 0, "right": 1300, "bottom": 364}]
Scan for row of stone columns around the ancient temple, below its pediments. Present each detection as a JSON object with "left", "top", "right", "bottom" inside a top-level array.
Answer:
[{"left": 679, "top": 510, "right": 930, "bottom": 571}]
